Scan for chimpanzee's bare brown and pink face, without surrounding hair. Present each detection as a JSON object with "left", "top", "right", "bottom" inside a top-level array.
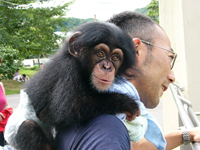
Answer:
[{"left": 91, "top": 43, "right": 123, "bottom": 91}]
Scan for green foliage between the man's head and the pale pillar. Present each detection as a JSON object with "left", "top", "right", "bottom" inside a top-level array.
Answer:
[{"left": 147, "top": 0, "right": 159, "bottom": 23}]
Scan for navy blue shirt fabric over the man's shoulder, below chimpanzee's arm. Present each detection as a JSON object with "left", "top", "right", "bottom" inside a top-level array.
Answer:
[{"left": 54, "top": 115, "right": 131, "bottom": 150}]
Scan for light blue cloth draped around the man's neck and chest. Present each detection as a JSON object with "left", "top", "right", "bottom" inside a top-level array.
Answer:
[{"left": 109, "top": 79, "right": 166, "bottom": 150}]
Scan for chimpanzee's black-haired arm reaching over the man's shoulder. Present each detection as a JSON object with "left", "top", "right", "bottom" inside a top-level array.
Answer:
[{"left": 75, "top": 93, "right": 139, "bottom": 123}]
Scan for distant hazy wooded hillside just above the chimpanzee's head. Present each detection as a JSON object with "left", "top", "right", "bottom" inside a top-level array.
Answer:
[{"left": 57, "top": 17, "right": 94, "bottom": 31}]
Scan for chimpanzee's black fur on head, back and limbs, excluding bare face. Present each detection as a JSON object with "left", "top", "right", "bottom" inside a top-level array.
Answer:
[{"left": 14, "top": 22, "right": 138, "bottom": 150}]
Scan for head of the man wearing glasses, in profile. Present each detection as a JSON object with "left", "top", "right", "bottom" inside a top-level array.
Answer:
[{"left": 108, "top": 11, "right": 175, "bottom": 108}]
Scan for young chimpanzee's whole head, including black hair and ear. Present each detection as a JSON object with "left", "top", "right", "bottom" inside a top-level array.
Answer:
[{"left": 68, "top": 22, "right": 136, "bottom": 91}]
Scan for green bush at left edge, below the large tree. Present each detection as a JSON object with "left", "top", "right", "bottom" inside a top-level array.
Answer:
[{"left": 0, "top": 45, "right": 21, "bottom": 80}]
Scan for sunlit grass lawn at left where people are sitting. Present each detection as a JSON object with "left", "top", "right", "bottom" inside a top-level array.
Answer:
[{"left": 1, "top": 69, "right": 37, "bottom": 95}]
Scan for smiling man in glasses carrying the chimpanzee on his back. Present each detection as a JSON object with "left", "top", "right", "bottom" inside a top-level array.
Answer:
[{"left": 56, "top": 12, "right": 200, "bottom": 150}]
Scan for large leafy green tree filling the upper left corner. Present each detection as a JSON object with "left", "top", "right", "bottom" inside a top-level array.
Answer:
[{"left": 0, "top": 0, "right": 73, "bottom": 68}]
